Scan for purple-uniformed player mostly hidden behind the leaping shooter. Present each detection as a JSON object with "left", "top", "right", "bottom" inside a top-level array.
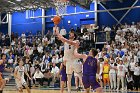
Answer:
[{"left": 59, "top": 63, "right": 67, "bottom": 93}]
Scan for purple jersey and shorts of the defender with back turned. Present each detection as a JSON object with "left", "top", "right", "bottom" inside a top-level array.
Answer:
[{"left": 82, "top": 56, "right": 100, "bottom": 90}]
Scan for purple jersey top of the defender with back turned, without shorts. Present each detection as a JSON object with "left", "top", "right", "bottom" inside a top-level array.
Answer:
[{"left": 83, "top": 56, "right": 97, "bottom": 76}]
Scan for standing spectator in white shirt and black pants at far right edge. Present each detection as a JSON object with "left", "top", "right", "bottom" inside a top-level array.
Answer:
[{"left": 134, "top": 63, "right": 140, "bottom": 90}]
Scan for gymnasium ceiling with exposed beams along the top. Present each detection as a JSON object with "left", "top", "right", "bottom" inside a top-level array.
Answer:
[{"left": 0, "top": 0, "right": 122, "bottom": 13}]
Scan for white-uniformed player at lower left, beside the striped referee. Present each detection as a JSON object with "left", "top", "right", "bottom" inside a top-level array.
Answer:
[{"left": 14, "top": 60, "right": 31, "bottom": 93}]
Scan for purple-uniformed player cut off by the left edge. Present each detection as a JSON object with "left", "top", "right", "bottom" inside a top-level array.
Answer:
[{"left": 0, "top": 54, "right": 12, "bottom": 93}]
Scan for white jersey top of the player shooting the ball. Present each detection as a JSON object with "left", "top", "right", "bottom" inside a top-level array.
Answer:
[{"left": 64, "top": 42, "right": 75, "bottom": 59}]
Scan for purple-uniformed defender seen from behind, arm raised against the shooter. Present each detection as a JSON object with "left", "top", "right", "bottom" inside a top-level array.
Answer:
[{"left": 74, "top": 44, "right": 103, "bottom": 93}]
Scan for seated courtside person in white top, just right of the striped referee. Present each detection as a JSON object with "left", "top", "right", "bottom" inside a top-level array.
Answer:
[{"left": 33, "top": 67, "right": 44, "bottom": 86}]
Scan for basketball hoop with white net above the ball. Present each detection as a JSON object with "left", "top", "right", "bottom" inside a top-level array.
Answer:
[{"left": 54, "top": 0, "right": 68, "bottom": 16}]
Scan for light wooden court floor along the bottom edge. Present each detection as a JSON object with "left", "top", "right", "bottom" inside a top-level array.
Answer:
[{"left": 3, "top": 90, "right": 140, "bottom": 93}]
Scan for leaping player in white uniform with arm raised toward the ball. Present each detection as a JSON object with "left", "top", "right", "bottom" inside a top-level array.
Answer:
[{"left": 55, "top": 26, "right": 81, "bottom": 93}]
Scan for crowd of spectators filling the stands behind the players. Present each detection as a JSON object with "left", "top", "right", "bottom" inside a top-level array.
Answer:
[{"left": 0, "top": 23, "right": 140, "bottom": 90}]
